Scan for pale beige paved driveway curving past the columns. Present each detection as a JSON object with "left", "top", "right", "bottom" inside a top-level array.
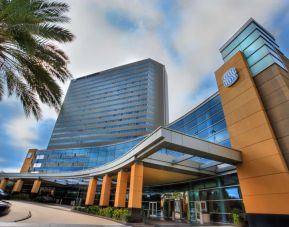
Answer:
[{"left": 0, "top": 201, "right": 124, "bottom": 227}]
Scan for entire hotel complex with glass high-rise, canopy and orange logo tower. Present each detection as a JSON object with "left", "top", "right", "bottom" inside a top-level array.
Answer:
[{"left": 0, "top": 19, "right": 289, "bottom": 227}]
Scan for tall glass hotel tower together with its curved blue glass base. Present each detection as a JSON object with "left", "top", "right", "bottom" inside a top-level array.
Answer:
[{"left": 30, "top": 59, "right": 168, "bottom": 172}]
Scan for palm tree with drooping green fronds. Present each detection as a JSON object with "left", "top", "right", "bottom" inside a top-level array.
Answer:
[{"left": 0, "top": 0, "right": 74, "bottom": 119}]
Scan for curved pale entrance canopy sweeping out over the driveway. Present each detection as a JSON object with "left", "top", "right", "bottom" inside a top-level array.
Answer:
[{"left": 0, "top": 127, "right": 242, "bottom": 179}]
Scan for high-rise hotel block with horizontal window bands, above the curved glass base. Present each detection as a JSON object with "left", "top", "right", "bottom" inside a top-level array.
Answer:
[{"left": 48, "top": 59, "right": 168, "bottom": 150}]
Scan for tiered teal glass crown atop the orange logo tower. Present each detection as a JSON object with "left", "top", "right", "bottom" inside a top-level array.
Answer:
[{"left": 220, "top": 19, "right": 287, "bottom": 76}]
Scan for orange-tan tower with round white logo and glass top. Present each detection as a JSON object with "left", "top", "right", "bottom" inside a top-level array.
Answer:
[{"left": 215, "top": 19, "right": 289, "bottom": 226}]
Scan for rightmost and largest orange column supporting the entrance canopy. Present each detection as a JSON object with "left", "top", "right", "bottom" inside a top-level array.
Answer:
[{"left": 128, "top": 163, "right": 143, "bottom": 209}]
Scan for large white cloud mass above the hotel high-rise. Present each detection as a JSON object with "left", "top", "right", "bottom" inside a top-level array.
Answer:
[{"left": 59, "top": 0, "right": 282, "bottom": 120}]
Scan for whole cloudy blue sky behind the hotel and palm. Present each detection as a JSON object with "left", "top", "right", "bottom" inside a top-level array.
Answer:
[{"left": 0, "top": 0, "right": 289, "bottom": 171}]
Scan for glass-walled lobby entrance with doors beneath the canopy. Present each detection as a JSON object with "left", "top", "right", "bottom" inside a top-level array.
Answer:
[{"left": 143, "top": 173, "right": 246, "bottom": 224}]
